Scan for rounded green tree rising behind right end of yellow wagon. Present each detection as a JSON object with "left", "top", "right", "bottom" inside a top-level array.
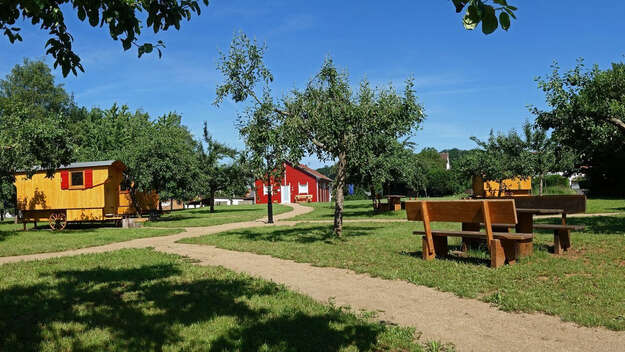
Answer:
[{"left": 74, "top": 105, "right": 200, "bottom": 212}]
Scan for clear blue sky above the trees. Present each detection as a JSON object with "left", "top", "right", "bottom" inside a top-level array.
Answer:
[{"left": 0, "top": 0, "right": 625, "bottom": 167}]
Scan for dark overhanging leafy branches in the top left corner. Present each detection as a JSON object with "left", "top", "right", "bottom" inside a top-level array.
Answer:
[{"left": 0, "top": 0, "right": 208, "bottom": 76}]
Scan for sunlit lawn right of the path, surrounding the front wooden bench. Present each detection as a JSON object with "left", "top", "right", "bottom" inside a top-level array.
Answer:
[{"left": 183, "top": 216, "right": 625, "bottom": 330}]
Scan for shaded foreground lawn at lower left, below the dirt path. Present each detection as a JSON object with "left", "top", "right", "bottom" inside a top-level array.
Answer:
[{"left": 0, "top": 249, "right": 448, "bottom": 351}]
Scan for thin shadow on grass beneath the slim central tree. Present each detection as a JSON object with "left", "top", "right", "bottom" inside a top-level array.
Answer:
[{"left": 234, "top": 224, "right": 378, "bottom": 243}]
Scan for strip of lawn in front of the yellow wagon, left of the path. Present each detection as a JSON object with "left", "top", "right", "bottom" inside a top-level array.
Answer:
[{"left": 0, "top": 222, "right": 181, "bottom": 258}]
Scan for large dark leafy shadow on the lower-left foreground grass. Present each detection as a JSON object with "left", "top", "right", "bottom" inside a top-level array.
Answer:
[{"left": 0, "top": 265, "right": 382, "bottom": 351}]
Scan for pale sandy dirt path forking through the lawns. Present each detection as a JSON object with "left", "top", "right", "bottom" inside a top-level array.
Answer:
[{"left": 0, "top": 204, "right": 625, "bottom": 351}]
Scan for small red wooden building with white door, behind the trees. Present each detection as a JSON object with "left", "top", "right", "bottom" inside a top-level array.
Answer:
[{"left": 254, "top": 164, "right": 332, "bottom": 204}]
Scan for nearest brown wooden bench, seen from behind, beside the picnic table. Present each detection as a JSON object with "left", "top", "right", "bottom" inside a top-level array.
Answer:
[{"left": 406, "top": 200, "right": 534, "bottom": 268}]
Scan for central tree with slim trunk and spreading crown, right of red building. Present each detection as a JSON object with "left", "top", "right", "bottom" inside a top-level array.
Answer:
[{"left": 285, "top": 66, "right": 424, "bottom": 236}]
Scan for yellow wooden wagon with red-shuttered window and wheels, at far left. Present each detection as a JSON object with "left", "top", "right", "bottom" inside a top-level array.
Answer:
[{"left": 15, "top": 160, "right": 126, "bottom": 230}]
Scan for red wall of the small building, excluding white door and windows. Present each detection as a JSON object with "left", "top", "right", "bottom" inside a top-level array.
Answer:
[{"left": 255, "top": 164, "right": 329, "bottom": 204}]
